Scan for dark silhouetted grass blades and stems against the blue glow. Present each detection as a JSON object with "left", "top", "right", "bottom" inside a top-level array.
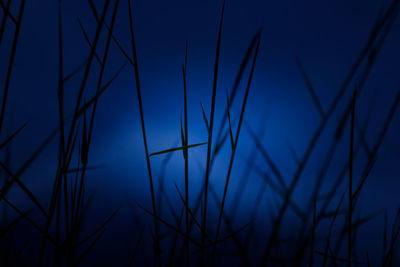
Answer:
[{"left": 0, "top": 0, "right": 400, "bottom": 266}]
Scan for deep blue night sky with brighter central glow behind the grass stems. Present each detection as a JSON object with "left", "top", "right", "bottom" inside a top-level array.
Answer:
[{"left": 0, "top": 0, "right": 400, "bottom": 266}]
